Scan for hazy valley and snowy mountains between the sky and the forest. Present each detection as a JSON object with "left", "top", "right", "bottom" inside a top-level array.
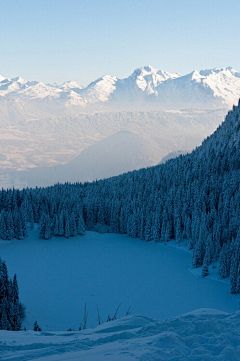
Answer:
[{"left": 0, "top": 66, "right": 240, "bottom": 187}]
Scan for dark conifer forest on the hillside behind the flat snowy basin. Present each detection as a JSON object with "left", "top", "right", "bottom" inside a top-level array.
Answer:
[{"left": 0, "top": 103, "right": 240, "bottom": 293}]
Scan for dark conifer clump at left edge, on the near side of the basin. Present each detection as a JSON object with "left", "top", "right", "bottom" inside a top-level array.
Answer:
[{"left": 0, "top": 258, "right": 24, "bottom": 331}]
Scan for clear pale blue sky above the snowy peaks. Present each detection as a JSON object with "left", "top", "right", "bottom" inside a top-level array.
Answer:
[{"left": 0, "top": 0, "right": 240, "bottom": 85}]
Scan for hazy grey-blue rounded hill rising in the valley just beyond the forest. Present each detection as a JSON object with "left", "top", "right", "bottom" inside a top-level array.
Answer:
[{"left": 3, "top": 131, "right": 162, "bottom": 188}]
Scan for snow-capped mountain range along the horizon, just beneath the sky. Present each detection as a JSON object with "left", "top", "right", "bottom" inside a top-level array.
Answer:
[{"left": 0, "top": 65, "right": 240, "bottom": 120}]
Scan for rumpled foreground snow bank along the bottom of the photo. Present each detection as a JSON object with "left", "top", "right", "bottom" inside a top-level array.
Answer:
[{"left": 0, "top": 310, "right": 240, "bottom": 361}]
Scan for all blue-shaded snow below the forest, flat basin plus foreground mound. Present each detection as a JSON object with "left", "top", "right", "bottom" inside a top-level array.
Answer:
[{"left": 0, "top": 230, "right": 240, "bottom": 361}]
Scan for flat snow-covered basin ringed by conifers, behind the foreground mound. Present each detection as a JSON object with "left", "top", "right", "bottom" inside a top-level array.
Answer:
[{"left": 0, "top": 230, "right": 239, "bottom": 331}]
